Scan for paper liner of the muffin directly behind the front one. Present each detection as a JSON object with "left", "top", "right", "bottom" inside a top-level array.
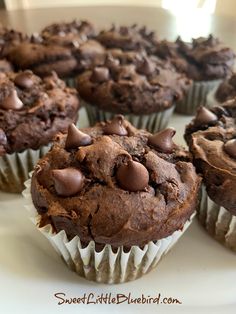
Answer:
[{"left": 85, "top": 103, "right": 175, "bottom": 133}]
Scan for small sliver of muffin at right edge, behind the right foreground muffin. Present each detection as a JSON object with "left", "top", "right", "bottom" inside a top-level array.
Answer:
[{"left": 207, "top": 73, "right": 236, "bottom": 107}]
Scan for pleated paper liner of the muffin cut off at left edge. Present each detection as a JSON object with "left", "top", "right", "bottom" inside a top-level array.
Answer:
[{"left": 0, "top": 145, "right": 50, "bottom": 193}]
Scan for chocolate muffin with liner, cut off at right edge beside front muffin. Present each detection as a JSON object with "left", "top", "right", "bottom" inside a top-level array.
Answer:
[{"left": 185, "top": 104, "right": 236, "bottom": 251}]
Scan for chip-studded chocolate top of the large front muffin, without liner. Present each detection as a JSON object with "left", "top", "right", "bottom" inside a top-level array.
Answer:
[{"left": 31, "top": 115, "right": 200, "bottom": 247}]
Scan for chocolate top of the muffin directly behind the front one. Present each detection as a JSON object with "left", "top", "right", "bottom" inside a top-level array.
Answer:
[{"left": 77, "top": 49, "right": 191, "bottom": 114}]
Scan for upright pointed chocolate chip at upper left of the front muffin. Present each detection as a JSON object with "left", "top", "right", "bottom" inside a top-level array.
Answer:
[{"left": 65, "top": 124, "right": 92, "bottom": 149}]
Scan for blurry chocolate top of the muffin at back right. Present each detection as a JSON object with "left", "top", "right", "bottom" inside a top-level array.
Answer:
[{"left": 156, "top": 35, "right": 235, "bottom": 81}]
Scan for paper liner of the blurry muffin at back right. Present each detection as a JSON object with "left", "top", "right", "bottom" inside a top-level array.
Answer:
[{"left": 175, "top": 80, "right": 222, "bottom": 115}]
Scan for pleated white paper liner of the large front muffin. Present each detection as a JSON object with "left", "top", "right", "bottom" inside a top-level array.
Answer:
[{"left": 23, "top": 180, "right": 195, "bottom": 284}]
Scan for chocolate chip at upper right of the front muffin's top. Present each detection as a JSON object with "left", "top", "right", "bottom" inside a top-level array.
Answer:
[{"left": 148, "top": 128, "right": 176, "bottom": 154}]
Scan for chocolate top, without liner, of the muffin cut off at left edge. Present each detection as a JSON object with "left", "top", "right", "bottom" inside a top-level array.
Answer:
[{"left": 0, "top": 71, "right": 79, "bottom": 156}]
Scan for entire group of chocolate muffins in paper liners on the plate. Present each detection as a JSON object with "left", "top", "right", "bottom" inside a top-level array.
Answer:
[{"left": 0, "top": 20, "right": 236, "bottom": 283}]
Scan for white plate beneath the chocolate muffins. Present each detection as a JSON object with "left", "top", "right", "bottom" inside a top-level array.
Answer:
[{"left": 0, "top": 109, "right": 236, "bottom": 314}]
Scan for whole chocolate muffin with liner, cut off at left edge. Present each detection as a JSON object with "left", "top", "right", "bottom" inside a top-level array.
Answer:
[{"left": 0, "top": 71, "right": 79, "bottom": 192}]
